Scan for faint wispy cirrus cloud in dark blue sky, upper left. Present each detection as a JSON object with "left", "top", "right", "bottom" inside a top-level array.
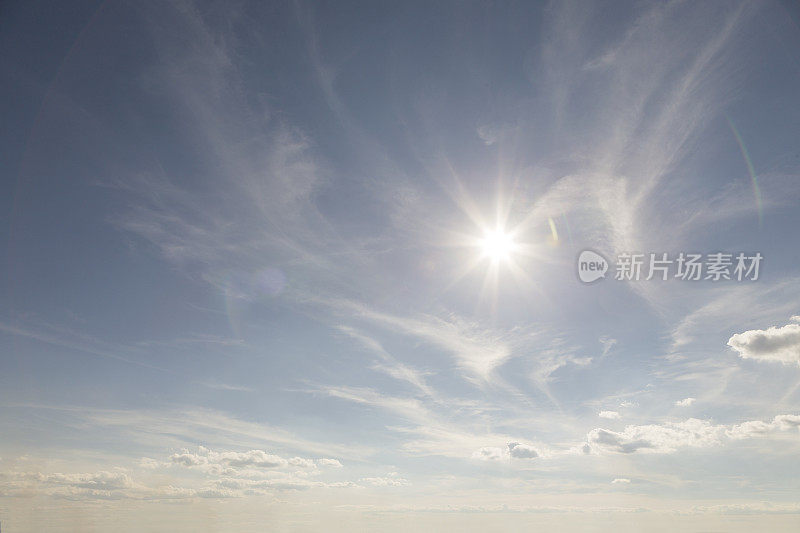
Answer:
[{"left": 105, "top": 1, "right": 382, "bottom": 312}]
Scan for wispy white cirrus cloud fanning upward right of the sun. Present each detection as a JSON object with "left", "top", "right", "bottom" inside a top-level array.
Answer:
[{"left": 531, "top": 0, "right": 753, "bottom": 278}]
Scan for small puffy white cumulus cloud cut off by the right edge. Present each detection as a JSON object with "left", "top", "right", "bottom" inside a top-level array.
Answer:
[{"left": 728, "top": 323, "right": 800, "bottom": 365}]
